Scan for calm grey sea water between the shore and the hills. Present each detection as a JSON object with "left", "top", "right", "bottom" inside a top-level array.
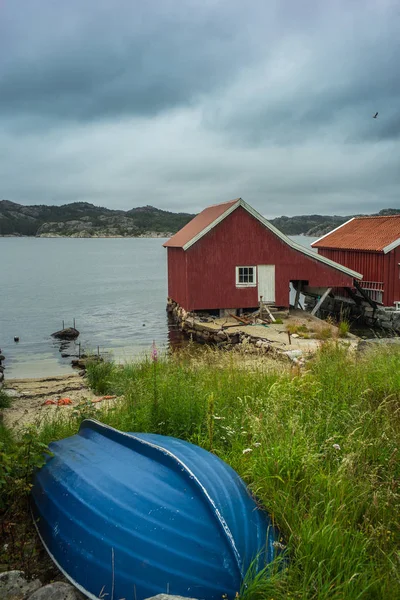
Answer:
[{"left": 0, "top": 236, "right": 315, "bottom": 378}]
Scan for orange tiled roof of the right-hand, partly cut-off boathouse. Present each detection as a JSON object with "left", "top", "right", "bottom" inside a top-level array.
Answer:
[{"left": 311, "top": 215, "right": 400, "bottom": 252}]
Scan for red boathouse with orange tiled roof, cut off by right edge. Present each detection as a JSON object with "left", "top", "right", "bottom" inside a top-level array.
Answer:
[{"left": 312, "top": 215, "right": 400, "bottom": 308}]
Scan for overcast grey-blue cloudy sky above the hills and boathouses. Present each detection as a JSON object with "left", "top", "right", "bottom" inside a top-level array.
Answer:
[{"left": 0, "top": 0, "right": 400, "bottom": 217}]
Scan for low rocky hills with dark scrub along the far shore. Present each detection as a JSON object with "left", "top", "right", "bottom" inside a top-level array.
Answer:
[{"left": 0, "top": 200, "right": 400, "bottom": 237}]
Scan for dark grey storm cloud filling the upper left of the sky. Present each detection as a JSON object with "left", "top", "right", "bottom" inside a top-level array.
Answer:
[{"left": 0, "top": 0, "right": 260, "bottom": 120}]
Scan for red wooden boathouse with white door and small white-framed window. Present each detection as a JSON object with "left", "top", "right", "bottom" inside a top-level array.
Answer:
[{"left": 164, "top": 198, "right": 362, "bottom": 311}]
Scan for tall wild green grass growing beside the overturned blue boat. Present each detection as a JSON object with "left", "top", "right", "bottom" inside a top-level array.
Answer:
[{"left": 0, "top": 343, "right": 400, "bottom": 600}]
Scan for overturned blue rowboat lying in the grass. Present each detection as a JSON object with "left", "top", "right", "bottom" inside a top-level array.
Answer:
[{"left": 32, "top": 420, "right": 277, "bottom": 600}]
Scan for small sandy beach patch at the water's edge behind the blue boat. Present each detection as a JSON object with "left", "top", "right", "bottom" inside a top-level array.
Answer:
[{"left": 3, "top": 374, "right": 115, "bottom": 428}]
